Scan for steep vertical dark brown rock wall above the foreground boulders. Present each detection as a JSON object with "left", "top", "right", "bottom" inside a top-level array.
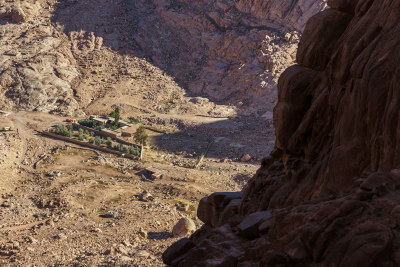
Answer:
[{"left": 256, "top": 1, "right": 400, "bottom": 206}]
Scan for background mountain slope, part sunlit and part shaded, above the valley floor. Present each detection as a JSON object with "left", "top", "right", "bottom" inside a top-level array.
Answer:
[{"left": 0, "top": 0, "right": 326, "bottom": 114}]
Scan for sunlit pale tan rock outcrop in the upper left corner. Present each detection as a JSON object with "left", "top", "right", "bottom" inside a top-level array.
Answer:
[{"left": 0, "top": 1, "right": 79, "bottom": 114}]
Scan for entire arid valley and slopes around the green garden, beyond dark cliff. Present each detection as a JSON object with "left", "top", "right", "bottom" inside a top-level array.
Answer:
[{"left": 0, "top": 0, "right": 332, "bottom": 266}]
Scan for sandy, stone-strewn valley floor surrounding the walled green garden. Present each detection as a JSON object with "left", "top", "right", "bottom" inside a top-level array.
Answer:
[{"left": 0, "top": 109, "right": 272, "bottom": 266}]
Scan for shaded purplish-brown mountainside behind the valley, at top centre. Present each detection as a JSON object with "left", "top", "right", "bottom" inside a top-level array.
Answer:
[{"left": 55, "top": 0, "right": 326, "bottom": 114}]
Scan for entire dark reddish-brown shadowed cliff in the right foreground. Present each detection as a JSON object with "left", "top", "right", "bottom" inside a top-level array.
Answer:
[{"left": 163, "top": 0, "right": 400, "bottom": 266}]
